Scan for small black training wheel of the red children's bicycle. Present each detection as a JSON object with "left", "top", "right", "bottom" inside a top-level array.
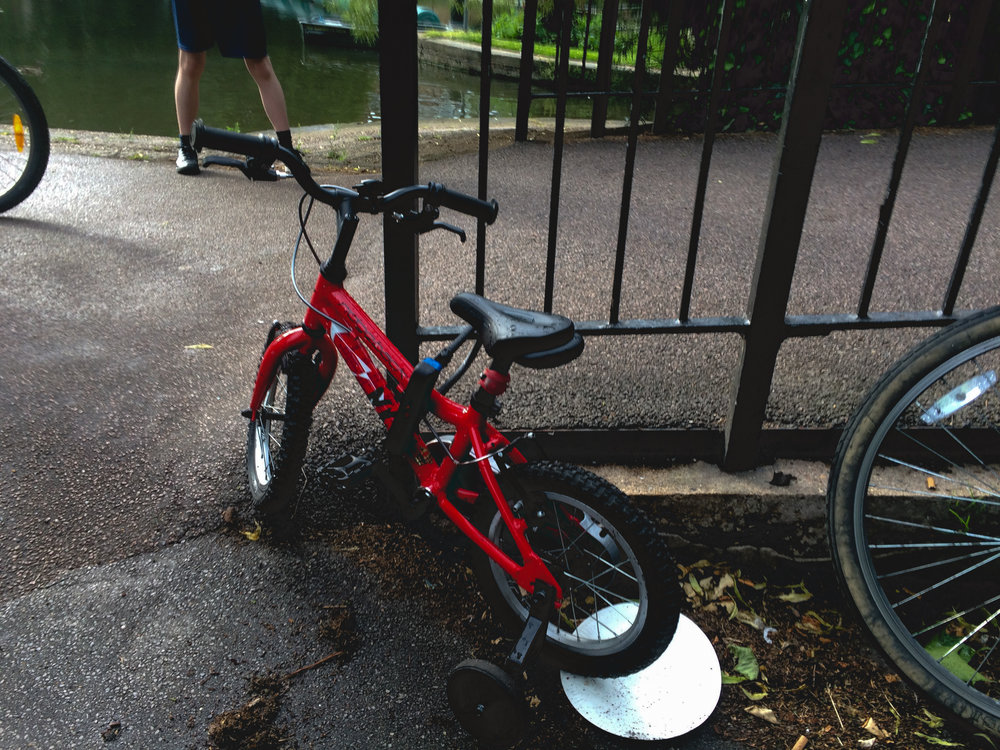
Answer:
[{"left": 448, "top": 659, "right": 527, "bottom": 747}]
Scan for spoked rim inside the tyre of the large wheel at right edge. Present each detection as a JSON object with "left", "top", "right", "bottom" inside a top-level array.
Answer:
[{"left": 853, "top": 337, "right": 1000, "bottom": 716}]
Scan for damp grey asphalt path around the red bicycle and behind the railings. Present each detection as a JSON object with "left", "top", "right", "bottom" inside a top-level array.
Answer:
[{"left": 0, "top": 132, "right": 1000, "bottom": 748}]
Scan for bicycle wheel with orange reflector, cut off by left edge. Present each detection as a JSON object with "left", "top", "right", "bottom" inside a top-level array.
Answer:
[{"left": 0, "top": 58, "right": 49, "bottom": 212}]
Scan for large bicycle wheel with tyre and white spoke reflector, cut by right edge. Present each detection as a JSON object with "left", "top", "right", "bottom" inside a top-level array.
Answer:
[{"left": 828, "top": 308, "right": 1000, "bottom": 733}]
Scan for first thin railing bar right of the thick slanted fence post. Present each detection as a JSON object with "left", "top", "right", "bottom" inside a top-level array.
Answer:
[{"left": 858, "top": 0, "right": 943, "bottom": 318}]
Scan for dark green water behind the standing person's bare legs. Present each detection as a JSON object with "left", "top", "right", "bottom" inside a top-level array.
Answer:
[{"left": 0, "top": 0, "right": 564, "bottom": 135}]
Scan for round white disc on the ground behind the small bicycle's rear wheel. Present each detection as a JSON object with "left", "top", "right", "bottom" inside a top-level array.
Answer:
[{"left": 562, "top": 605, "right": 722, "bottom": 740}]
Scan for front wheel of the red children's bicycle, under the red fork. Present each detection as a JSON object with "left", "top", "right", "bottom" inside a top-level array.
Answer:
[{"left": 246, "top": 324, "right": 319, "bottom": 529}]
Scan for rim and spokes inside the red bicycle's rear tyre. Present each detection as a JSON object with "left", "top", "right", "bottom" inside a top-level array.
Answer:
[{"left": 490, "top": 492, "right": 648, "bottom": 656}]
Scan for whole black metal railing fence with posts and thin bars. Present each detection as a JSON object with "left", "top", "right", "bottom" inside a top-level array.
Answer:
[{"left": 380, "top": 0, "right": 1000, "bottom": 469}]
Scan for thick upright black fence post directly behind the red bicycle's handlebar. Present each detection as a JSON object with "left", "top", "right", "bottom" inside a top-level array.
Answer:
[{"left": 378, "top": 0, "right": 419, "bottom": 362}]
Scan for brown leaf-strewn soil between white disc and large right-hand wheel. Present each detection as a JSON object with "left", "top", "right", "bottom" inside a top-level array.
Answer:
[{"left": 680, "top": 561, "right": 993, "bottom": 750}]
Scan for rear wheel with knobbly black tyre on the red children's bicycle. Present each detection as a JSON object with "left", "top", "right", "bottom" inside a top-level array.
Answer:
[{"left": 474, "top": 462, "right": 682, "bottom": 677}]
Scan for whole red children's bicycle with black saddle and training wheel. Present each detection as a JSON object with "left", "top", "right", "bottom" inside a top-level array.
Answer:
[{"left": 194, "top": 123, "right": 681, "bottom": 741}]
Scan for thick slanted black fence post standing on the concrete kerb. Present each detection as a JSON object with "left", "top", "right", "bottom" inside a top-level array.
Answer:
[{"left": 723, "top": 0, "right": 847, "bottom": 471}]
